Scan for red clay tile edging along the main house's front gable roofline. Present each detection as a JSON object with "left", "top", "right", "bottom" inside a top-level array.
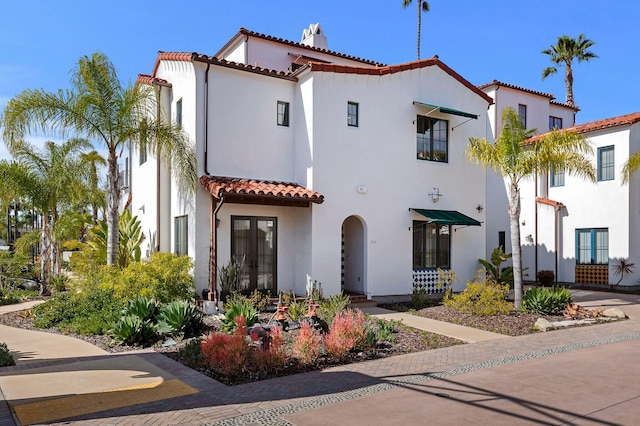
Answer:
[{"left": 310, "top": 56, "right": 493, "bottom": 104}]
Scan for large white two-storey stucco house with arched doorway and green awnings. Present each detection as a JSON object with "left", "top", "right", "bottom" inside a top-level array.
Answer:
[{"left": 130, "top": 24, "right": 492, "bottom": 298}]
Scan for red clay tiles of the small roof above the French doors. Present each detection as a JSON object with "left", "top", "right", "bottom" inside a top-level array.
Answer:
[{"left": 200, "top": 176, "right": 324, "bottom": 204}]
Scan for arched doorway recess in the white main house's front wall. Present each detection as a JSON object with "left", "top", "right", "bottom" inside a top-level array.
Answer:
[{"left": 342, "top": 216, "right": 367, "bottom": 294}]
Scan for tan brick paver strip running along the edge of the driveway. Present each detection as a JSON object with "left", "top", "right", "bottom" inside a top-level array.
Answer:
[{"left": 0, "top": 319, "right": 640, "bottom": 425}]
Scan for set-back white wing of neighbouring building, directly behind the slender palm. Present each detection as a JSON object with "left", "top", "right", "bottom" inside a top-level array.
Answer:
[{"left": 479, "top": 80, "right": 578, "bottom": 260}]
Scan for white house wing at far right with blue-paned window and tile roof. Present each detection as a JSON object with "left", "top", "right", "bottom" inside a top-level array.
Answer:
[{"left": 520, "top": 113, "right": 640, "bottom": 285}]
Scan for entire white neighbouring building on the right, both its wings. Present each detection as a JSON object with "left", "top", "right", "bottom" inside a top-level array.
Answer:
[{"left": 480, "top": 81, "right": 640, "bottom": 285}]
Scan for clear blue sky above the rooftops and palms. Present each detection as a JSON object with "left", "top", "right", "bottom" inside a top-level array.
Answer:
[{"left": 0, "top": 0, "right": 640, "bottom": 158}]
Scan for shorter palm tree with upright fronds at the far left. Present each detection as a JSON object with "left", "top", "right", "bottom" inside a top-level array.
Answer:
[{"left": 0, "top": 139, "right": 91, "bottom": 294}]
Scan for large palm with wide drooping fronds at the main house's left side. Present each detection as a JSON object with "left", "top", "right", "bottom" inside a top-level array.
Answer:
[{"left": 2, "top": 52, "right": 197, "bottom": 265}]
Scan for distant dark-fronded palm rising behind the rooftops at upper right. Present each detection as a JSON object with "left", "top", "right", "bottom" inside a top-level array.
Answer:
[{"left": 542, "top": 34, "right": 598, "bottom": 106}]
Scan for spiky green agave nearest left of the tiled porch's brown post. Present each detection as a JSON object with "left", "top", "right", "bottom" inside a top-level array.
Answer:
[{"left": 157, "top": 300, "right": 204, "bottom": 338}]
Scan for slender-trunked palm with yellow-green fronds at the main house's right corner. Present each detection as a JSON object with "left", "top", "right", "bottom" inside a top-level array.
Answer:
[{"left": 467, "top": 108, "right": 596, "bottom": 309}]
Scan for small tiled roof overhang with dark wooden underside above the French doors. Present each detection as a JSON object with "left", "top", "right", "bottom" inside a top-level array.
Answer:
[{"left": 200, "top": 175, "right": 324, "bottom": 207}]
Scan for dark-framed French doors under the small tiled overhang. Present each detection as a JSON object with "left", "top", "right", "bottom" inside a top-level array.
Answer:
[{"left": 231, "top": 216, "right": 278, "bottom": 295}]
